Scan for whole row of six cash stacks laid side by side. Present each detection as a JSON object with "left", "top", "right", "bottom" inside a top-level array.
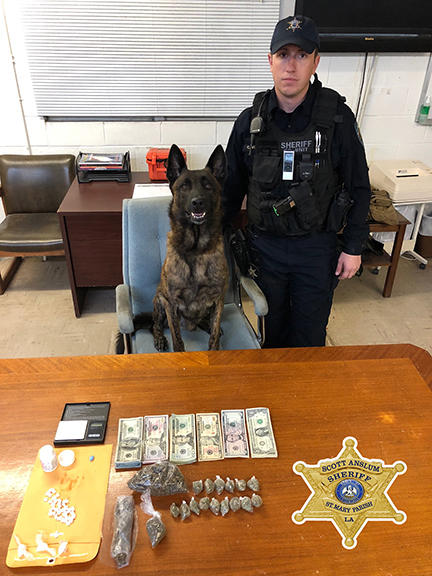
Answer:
[{"left": 115, "top": 408, "right": 278, "bottom": 469}]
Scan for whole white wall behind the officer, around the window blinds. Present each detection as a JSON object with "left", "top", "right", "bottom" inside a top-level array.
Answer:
[{"left": 0, "top": 0, "right": 432, "bottom": 219}]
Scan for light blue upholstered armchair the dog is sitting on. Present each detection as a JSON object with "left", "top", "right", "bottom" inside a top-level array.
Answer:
[{"left": 116, "top": 197, "right": 267, "bottom": 353}]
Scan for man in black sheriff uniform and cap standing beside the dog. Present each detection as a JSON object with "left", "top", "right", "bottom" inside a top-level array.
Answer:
[{"left": 223, "top": 16, "right": 370, "bottom": 348}]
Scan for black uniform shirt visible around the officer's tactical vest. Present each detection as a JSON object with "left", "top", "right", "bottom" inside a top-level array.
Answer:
[{"left": 222, "top": 79, "right": 370, "bottom": 254}]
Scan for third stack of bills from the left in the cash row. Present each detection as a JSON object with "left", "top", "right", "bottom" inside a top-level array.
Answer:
[{"left": 169, "top": 414, "right": 197, "bottom": 464}]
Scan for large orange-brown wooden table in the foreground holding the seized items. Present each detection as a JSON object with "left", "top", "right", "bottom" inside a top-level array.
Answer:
[{"left": 0, "top": 345, "right": 432, "bottom": 576}]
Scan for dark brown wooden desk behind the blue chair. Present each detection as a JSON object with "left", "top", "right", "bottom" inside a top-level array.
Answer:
[{"left": 58, "top": 172, "right": 150, "bottom": 318}]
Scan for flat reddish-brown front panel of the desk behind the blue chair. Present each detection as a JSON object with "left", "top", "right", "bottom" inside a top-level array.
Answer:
[{"left": 65, "top": 213, "right": 123, "bottom": 287}]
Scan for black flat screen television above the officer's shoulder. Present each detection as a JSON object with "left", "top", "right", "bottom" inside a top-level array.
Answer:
[{"left": 295, "top": 0, "right": 432, "bottom": 52}]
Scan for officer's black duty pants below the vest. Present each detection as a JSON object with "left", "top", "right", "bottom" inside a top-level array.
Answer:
[{"left": 250, "top": 232, "right": 338, "bottom": 348}]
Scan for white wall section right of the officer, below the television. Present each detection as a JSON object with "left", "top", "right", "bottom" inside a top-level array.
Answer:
[{"left": 319, "top": 53, "right": 432, "bottom": 166}]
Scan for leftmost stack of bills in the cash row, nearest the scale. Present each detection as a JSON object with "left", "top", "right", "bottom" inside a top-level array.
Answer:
[{"left": 114, "top": 416, "right": 143, "bottom": 470}]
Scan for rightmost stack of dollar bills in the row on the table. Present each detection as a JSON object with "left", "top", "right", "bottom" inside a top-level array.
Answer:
[{"left": 246, "top": 408, "right": 278, "bottom": 458}]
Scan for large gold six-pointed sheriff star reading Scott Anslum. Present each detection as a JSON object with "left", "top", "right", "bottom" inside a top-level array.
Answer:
[{"left": 292, "top": 436, "right": 407, "bottom": 550}]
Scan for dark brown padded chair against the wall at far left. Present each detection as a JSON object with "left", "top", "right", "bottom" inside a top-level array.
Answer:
[{"left": 0, "top": 154, "right": 75, "bottom": 294}]
